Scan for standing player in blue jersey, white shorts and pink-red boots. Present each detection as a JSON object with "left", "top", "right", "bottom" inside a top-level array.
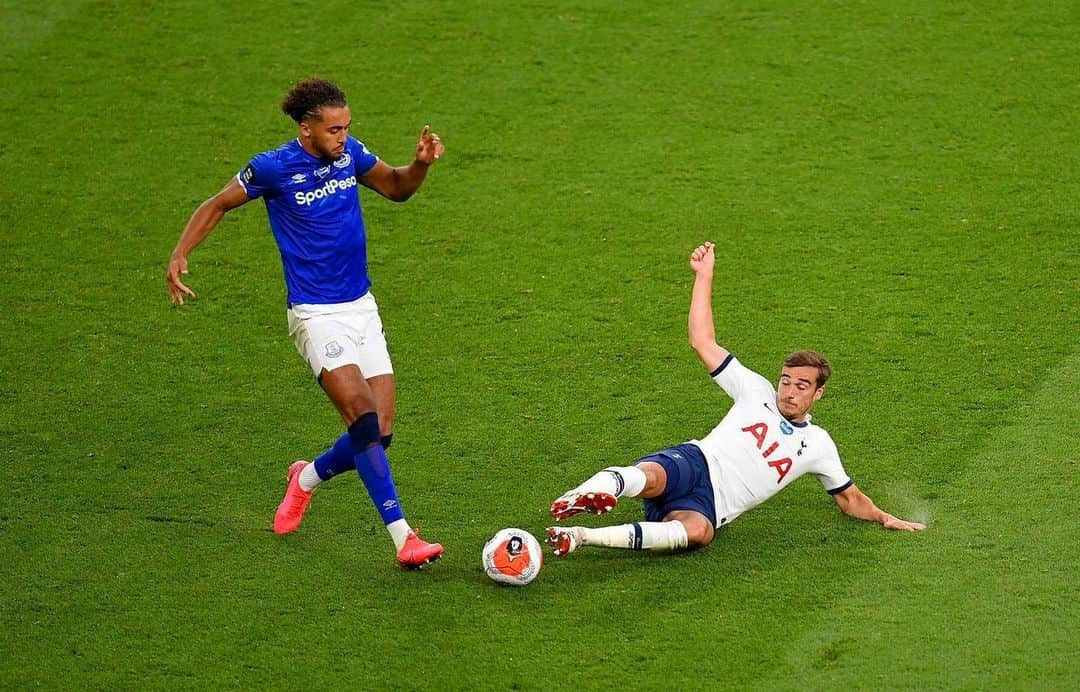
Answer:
[{"left": 166, "top": 79, "right": 444, "bottom": 569}]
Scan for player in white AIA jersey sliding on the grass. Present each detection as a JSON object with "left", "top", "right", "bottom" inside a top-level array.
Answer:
[{"left": 545, "top": 243, "right": 926, "bottom": 556}]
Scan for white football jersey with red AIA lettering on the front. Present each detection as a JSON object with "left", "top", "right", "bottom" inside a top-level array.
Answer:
[{"left": 690, "top": 356, "right": 851, "bottom": 526}]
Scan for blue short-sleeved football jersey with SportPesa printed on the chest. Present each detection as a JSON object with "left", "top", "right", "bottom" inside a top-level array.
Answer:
[{"left": 237, "top": 136, "right": 379, "bottom": 306}]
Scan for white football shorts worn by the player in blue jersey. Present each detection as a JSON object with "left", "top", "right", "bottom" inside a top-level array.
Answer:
[{"left": 288, "top": 293, "right": 394, "bottom": 378}]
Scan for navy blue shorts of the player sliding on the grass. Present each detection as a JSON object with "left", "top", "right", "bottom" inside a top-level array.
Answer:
[{"left": 637, "top": 443, "right": 716, "bottom": 527}]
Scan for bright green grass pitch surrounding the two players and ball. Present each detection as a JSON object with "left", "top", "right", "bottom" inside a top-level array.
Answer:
[{"left": 0, "top": 0, "right": 1080, "bottom": 690}]
